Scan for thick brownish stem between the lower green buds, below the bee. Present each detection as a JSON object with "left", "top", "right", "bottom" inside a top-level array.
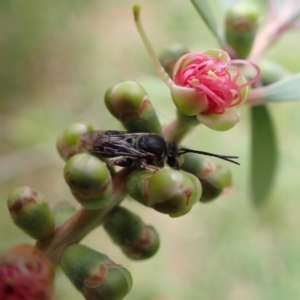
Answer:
[{"left": 36, "top": 168, "right": 133, "bottom": 263}]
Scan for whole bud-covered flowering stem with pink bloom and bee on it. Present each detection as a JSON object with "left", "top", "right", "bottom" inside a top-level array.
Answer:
[{"left": 0, "top": 1, "right": 268, "bottom": 300}]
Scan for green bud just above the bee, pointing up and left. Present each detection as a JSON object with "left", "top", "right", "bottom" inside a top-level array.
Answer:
[{"left": 104, "top": 81, "right": 161, "bottom": 133}]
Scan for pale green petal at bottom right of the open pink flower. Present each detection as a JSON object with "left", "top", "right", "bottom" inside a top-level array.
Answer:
[{"left": 197, "top": 108, "right": 240, "bottom": 131}]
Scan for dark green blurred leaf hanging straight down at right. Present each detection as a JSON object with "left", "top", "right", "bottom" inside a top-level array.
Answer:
[{"left": 250, "top": 105, "right": 277, "bottom": 205}]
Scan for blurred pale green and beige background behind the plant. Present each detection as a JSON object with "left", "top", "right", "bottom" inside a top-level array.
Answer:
[{"left": 0, "top": 0, "right": 300, "bottom": 300}]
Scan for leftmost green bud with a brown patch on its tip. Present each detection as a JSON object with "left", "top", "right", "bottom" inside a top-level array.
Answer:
[{"left": 7, "top": 186, "right": 55, "bottom": 240}]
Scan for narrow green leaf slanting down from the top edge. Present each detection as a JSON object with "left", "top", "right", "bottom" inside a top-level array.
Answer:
[{"left": 191, "top": 0, "right": 225, "bottom": 46}]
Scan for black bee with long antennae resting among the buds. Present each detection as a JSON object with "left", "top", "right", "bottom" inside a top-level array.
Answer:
[{"left": 78, "top": 131, "right": 239, "bottom": 170}]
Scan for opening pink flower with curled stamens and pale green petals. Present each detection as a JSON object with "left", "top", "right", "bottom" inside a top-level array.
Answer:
[{"left": 171, "top": 50, "right": 260, "bottom": 130}]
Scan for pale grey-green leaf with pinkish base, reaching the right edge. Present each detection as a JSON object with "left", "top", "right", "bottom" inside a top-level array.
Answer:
[{"left": 247, "top": 73, "right": 300, "bottom": 104}]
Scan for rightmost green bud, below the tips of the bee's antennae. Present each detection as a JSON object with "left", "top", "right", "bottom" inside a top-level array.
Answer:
[{"left": 200, "top": 164, "right": 232, "bottom": 202}]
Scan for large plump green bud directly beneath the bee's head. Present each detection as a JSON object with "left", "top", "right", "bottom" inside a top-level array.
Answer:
[{"left": 126, "top": 169, "right": 202, "bottom": 217}]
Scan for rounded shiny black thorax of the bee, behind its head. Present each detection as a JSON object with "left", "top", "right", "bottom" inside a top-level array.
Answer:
[{"left": 138, "top": 134, "right": 166, "bottom": 156}]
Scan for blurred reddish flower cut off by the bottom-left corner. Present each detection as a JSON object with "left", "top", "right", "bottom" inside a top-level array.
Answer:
[{"left": 0, "top": 245, "right": 53, "bottom": 300}]
